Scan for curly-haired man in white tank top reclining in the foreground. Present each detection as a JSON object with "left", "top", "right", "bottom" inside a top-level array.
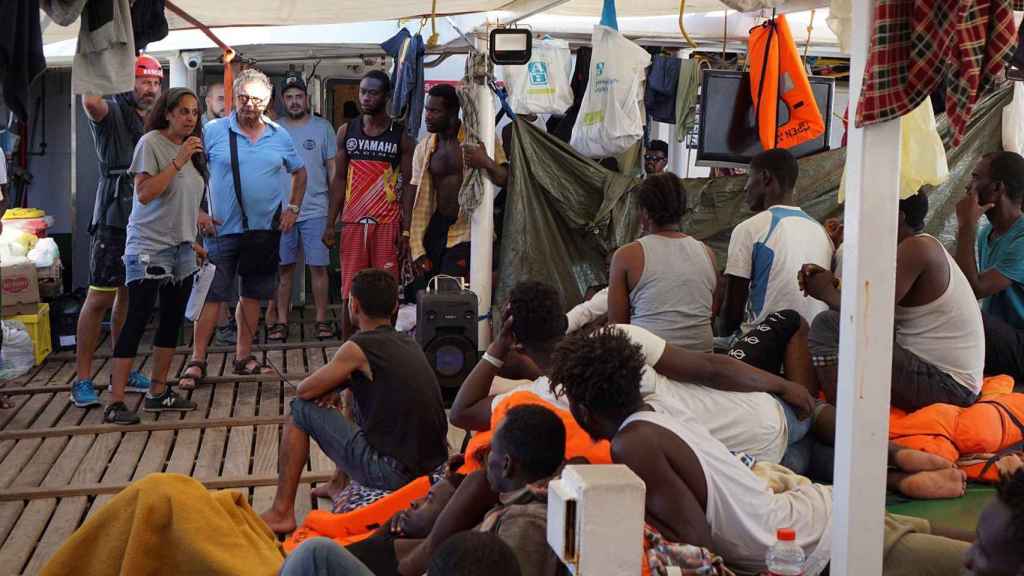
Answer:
[{"left": 551, "top": 328, "right": 967, "bottom": 575}]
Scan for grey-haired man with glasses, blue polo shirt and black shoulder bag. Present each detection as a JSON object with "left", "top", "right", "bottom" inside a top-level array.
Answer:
[{"left": 179, "top": 69, "right": 306, "bottom": 389}]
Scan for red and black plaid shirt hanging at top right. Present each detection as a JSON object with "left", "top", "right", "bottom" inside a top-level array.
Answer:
[{"left": 856, "top": 0, "right": 1017, "bottom": 146}]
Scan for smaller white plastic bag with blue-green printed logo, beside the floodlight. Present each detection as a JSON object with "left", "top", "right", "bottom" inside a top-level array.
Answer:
[{"left": 500, "top": 38, "right": 572, "bottom": 114}]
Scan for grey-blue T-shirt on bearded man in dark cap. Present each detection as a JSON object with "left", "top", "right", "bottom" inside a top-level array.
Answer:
[{"left": 280, "top": 116, "right": 338, "bottom": 220}]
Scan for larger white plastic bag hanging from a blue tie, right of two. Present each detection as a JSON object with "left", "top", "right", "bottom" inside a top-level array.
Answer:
[{"left": 569, "top": 26, "right": 651, "bottom": 158}]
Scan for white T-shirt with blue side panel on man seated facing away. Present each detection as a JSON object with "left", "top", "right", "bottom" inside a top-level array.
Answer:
[{"left": 725, "top": 206, "right": 834, "bottom": 333}]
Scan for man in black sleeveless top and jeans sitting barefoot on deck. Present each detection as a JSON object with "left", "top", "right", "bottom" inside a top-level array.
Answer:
[{"left": 262, "top": 269, "right": 447, "bottom": 534}]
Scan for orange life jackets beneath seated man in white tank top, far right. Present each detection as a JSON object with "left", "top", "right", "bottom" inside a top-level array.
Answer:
[{"left": 889, "top": 376, "right": 1024, "bottom": 483}]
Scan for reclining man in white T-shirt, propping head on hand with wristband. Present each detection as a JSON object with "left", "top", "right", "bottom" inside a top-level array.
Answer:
[{"left": 450, "top": 282, "right": 820, "bottom": 463}]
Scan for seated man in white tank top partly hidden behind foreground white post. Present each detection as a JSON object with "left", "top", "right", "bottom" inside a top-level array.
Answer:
[{"left": 799, "top": 193, "right": 985, "bottom": 411}]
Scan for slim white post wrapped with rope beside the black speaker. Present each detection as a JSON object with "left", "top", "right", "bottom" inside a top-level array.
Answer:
[{"left": 469, "top": 37, "right": 496, "bottom": 351}]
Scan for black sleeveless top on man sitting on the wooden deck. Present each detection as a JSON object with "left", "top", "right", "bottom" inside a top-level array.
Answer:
[{"left": 349, "top": 326, "right": 447, "bottom": 477}]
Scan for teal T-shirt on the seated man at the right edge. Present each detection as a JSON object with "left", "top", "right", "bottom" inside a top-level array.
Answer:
[{"left": 978, "top": 217, "right": 1024, "bottom": 330}]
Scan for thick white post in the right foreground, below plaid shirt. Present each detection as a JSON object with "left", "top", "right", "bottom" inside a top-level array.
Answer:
[{"left": 831, "top": 0, "right": 900, "bottom": 576}]
